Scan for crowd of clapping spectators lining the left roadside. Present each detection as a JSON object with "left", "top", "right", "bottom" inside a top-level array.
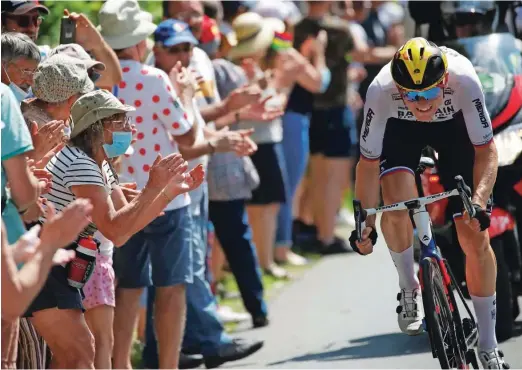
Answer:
[{"left": 1, "top": 0, "right": 405, "bottom": 369}]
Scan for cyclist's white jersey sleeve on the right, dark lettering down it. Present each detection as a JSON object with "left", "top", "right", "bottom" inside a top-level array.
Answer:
[{"left": 457, "top": 63, "right": 493, "bottom": 146}]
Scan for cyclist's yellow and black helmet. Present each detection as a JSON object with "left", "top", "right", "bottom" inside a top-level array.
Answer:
[{"left": 391, "top": 37, "right": 448, "bottom": 91}]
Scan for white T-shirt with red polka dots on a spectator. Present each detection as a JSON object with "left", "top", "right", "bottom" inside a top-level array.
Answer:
[{"left": 113, "top": 60, "right": 192, "bottom": 211}]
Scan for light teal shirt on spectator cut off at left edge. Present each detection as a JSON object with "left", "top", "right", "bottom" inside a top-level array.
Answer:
[{"left": 0, "top": 84, "right": 33, "bottom": 244}]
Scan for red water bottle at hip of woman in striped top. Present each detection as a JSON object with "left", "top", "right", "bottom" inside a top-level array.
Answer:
[{"left": 67, "top": 236, "right": 98, "bottom": 289}]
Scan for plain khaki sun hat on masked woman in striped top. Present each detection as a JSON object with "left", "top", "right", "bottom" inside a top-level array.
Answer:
[{"left": 71, "top": 89, "right": 136, "bottom": 139}]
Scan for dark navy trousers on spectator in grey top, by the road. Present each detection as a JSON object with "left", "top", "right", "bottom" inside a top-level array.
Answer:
[{"left": 209, "top": 199, "right": 267, "bottom": 317}]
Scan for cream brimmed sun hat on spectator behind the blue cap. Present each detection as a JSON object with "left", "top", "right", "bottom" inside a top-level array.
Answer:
[{"left": 228, "top": 12, "right": 285, "bottom": 59}]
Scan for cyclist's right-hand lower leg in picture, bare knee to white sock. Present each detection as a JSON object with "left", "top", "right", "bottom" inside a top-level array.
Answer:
[{"left": 455, "top": 218, "right": 497, "bottom": 350}]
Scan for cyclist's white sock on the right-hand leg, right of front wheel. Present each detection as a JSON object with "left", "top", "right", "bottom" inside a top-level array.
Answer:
[{"left": 471, "top": 293, "right": 497, "bottom": 351}]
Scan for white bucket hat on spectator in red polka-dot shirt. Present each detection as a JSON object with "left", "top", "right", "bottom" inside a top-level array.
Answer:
[{"left": 98, "top": 0, "right": 156, "bottom": 50}]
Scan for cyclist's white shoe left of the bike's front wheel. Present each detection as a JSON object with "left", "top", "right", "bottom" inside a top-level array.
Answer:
[{"left": 396, "top": 288, "right": 424, "bottom": 335}]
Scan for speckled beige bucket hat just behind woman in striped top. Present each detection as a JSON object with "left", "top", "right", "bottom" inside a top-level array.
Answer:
[{"left": 33, "top": 54, "right": 94, "bottom": 103}]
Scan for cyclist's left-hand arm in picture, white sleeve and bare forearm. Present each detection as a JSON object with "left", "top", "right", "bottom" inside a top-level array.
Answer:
[{"left": 355, "top": 81, "right": 389, "bottom": 226}]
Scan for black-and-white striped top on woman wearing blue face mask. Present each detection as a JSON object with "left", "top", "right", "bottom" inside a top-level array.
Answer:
[{"left": 42, "top": 146, "right": 118, "bottom": 235}]
